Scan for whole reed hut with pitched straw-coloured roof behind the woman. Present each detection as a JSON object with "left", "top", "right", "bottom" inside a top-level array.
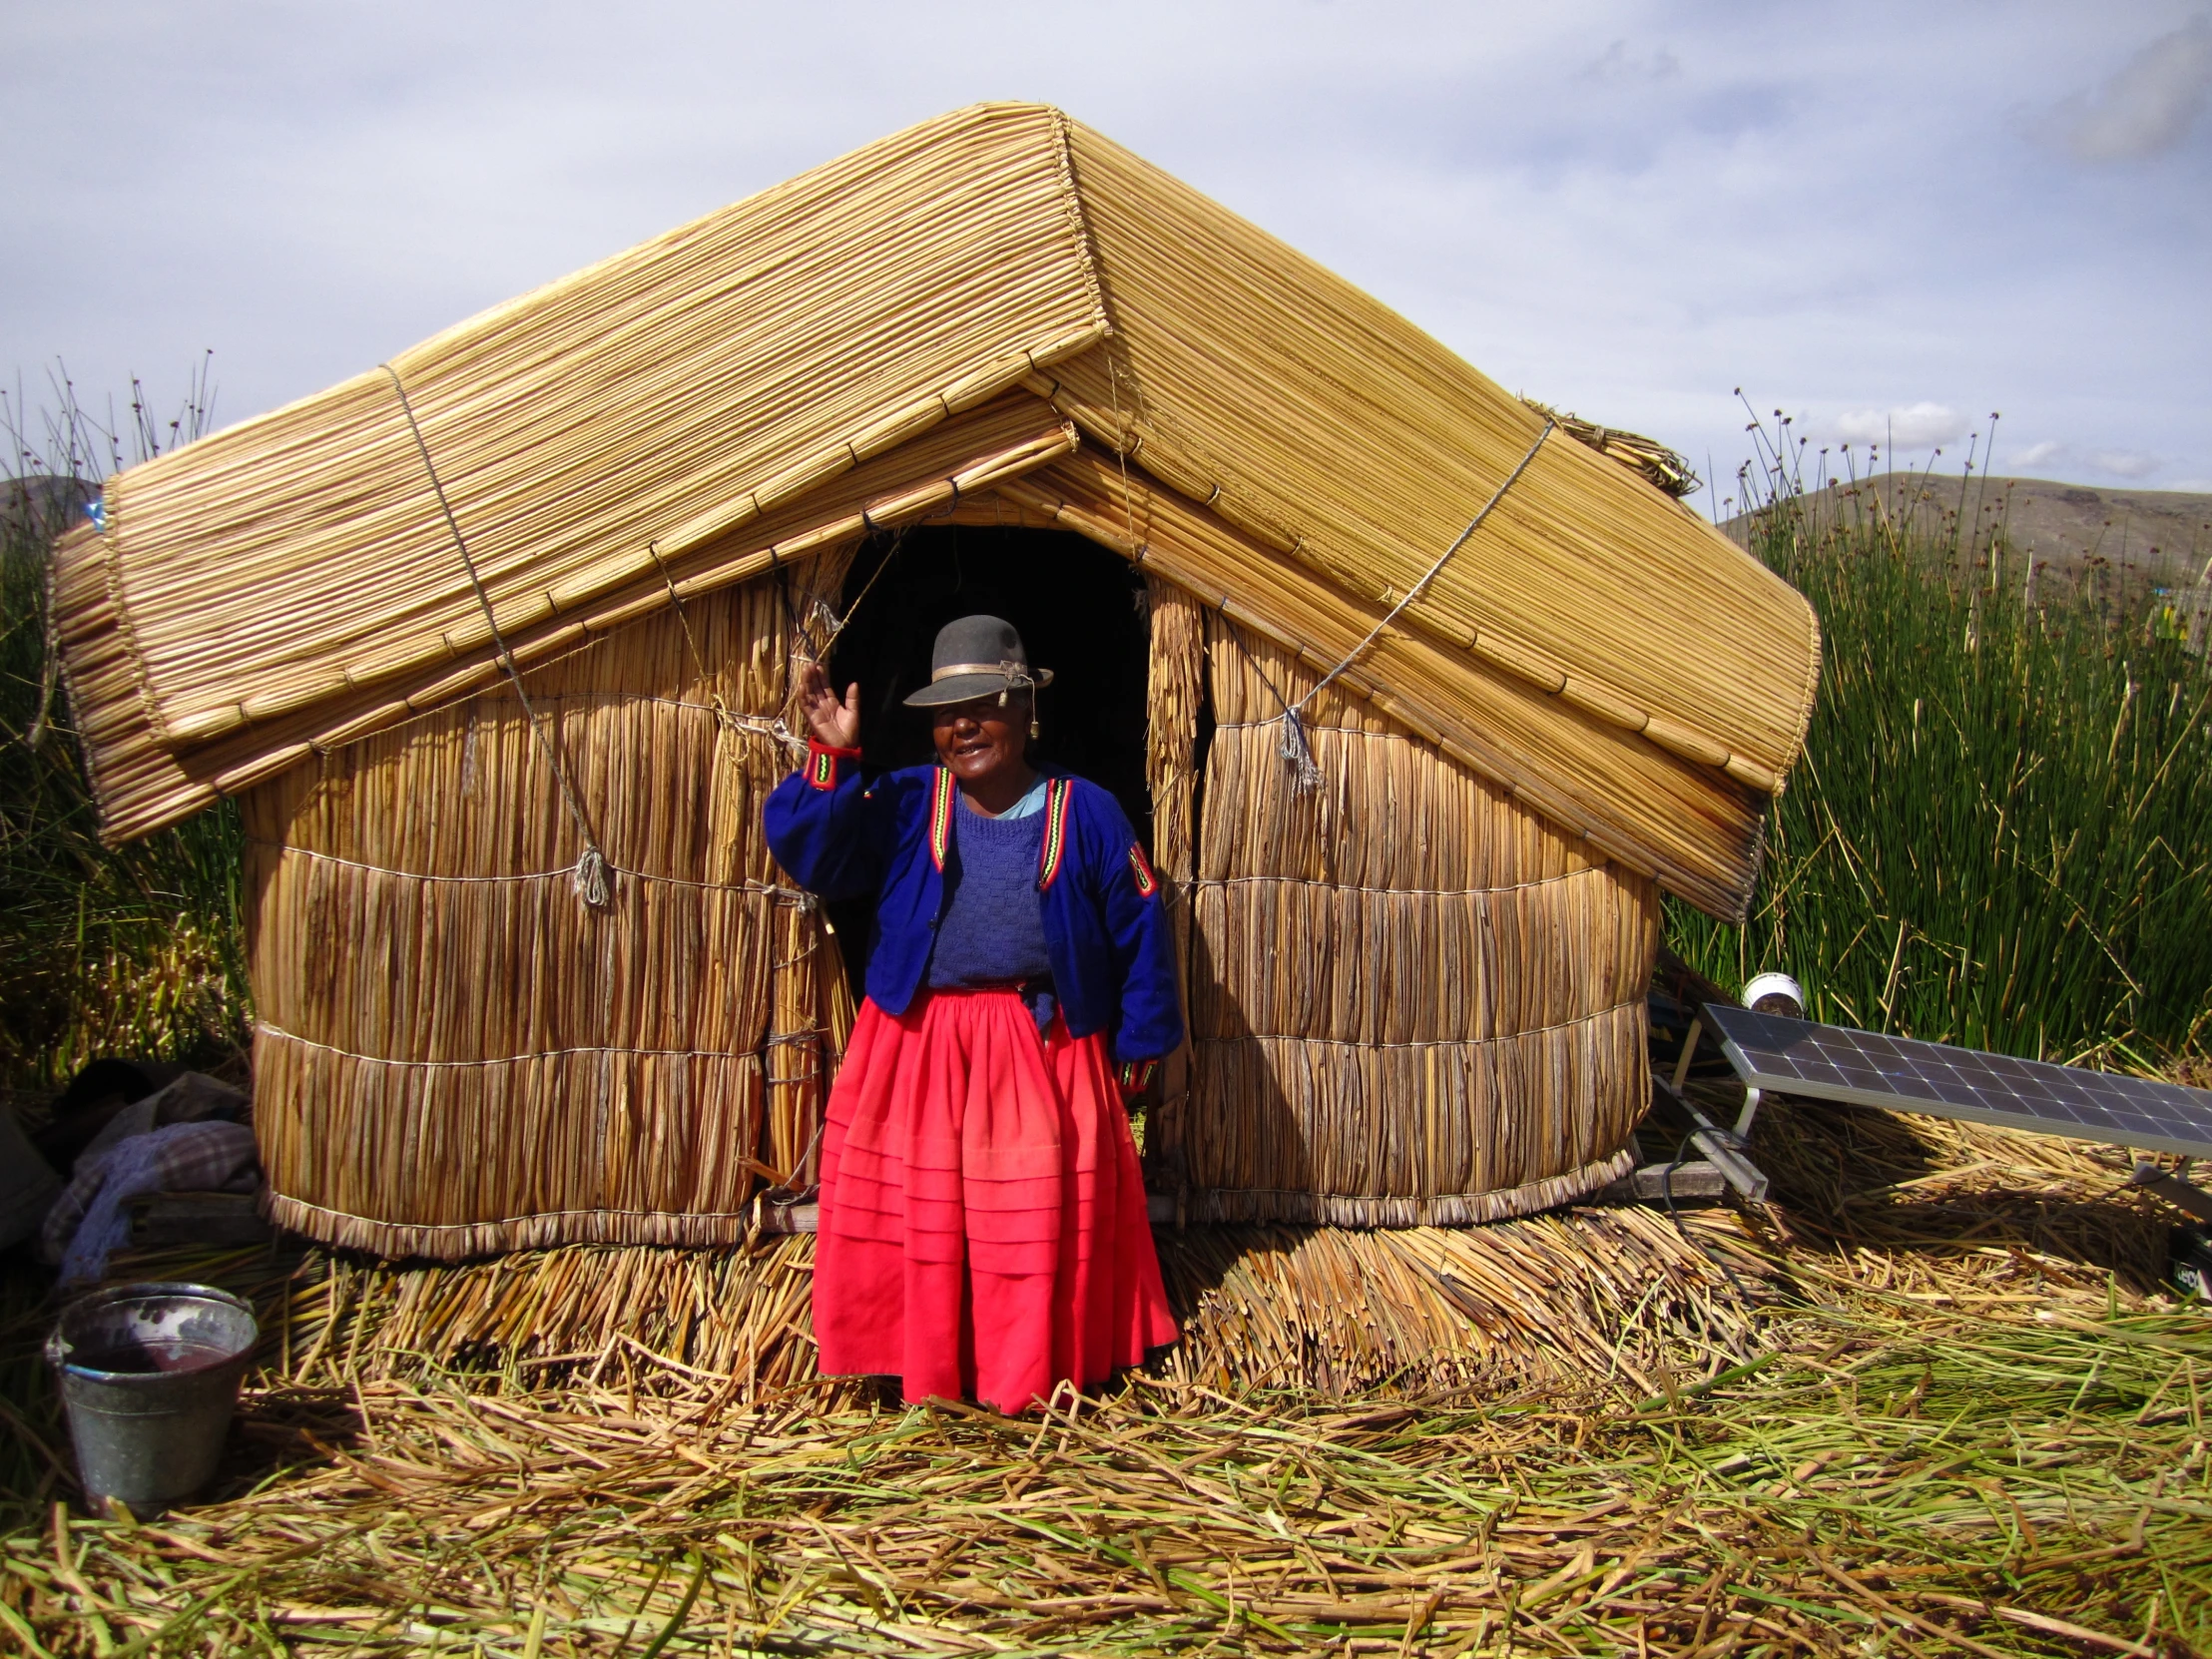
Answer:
[{"left": 53, "top": 104, "right": 1819, "bottom": 1259}]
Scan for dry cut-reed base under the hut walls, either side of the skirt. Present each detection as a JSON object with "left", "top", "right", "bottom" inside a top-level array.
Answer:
[{"left": 56, "top": 1210, "right": 1774, "bottom": 1400}]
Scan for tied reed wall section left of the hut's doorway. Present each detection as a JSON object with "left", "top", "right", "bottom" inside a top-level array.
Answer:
[{"left": 244, "top": 555, "right": 849, "bottom": 1259}]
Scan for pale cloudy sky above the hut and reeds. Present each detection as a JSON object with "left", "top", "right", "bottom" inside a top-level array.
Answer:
[{"left": 0, "top": 0, "right": 2212, "bottom": 504}]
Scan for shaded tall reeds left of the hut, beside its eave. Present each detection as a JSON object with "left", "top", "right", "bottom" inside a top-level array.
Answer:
[{"left": 0, "top": 369, "right": 246, "bottom": 1088}]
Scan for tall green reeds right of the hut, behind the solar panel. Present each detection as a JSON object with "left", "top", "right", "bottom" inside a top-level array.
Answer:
[{"left": 1670, "top": 408, "right": 2212, "bottom": 1064}]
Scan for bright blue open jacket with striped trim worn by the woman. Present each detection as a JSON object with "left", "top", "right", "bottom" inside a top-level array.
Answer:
[{"left": 764, "top": 744, "right": 1184, "bottom": 1082}]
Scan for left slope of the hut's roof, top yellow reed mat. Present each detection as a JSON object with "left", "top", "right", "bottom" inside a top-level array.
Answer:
[{"left": 90, "top": 106, "right": 1104, "bottom": 744}]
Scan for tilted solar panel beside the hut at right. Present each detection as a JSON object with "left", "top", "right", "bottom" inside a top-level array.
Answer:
[{"left": 1703, "top": 1002, "right": 2212, "bottom": 1157}]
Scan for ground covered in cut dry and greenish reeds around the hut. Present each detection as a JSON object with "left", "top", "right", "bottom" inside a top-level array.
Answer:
[{"left": 0, "top": 1092, "right": 2212, "bottom": 1659}]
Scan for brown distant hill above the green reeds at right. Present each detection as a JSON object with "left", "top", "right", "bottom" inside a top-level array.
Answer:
[{"left": 1723, "top": 473, "right": 2212, "bottom": 588}]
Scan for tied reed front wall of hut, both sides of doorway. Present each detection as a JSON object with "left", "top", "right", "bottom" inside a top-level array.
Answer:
[{"left": 244, "top": 513, "right": 1657, "bottom": 1259}]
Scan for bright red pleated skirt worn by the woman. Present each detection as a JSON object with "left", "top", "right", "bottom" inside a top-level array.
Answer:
[{"left": 814, "top": 991, "right": 1177, "bottom": 1411}]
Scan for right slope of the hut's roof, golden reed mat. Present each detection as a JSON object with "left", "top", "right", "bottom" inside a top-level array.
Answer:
[{"left": 1051, "top": 122, "right": 1816, "bottom": 788}]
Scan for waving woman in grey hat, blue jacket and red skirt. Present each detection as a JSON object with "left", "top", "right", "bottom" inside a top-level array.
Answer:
[{"left": 766, "top": 617, "right": 1184, "bottom": 1411}]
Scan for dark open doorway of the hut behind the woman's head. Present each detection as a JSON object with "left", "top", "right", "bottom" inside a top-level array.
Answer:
[{"left": 830, "top": 524, "right": 1153, "bottom": 984}]
